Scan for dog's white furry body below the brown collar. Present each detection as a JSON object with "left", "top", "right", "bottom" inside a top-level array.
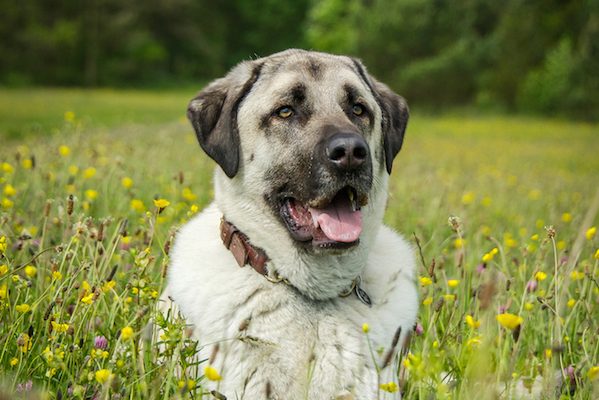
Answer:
[{"left": 163, "top": 198, "right": 418, "bottom": 399}]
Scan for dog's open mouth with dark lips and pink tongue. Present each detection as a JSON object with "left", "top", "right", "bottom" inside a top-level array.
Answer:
[{"left": 280, "top": 186, "right": 368, "bottom": 248}]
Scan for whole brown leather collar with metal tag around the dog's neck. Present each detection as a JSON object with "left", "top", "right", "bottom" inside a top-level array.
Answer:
[{"left": 220, "top": 216, "right": 372, "bottom": 307}]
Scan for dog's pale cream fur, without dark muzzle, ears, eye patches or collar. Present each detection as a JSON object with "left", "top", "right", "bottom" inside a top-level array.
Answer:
[{"left": 162, "top": 51, "right": 418, "bottom": 400}]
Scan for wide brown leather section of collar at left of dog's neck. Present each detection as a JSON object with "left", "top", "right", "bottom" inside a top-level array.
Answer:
[{"left": 220, "top": 217, "right": 268, "bottom": 276}]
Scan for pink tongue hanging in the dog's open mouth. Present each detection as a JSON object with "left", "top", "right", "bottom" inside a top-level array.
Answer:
[{"left": 310, "top": 196, "right": 362, "bottom": 243}]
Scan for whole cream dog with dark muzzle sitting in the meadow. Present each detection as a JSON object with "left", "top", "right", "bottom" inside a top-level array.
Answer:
[{"left": 162, "top": 50, "right": 418, "bottom": 400}]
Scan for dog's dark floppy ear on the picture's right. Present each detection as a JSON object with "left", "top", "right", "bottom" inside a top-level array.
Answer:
[{"left": 352, "top": 59, "right": 410, "bottom": 173}]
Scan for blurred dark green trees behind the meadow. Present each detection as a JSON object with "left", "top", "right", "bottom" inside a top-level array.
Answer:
[{"left": 0, "top": 0, "right": 599, "bottom": 118}]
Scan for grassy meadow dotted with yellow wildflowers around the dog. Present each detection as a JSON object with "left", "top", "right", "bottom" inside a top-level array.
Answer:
[{"left": 0, "top": 89, "right": 599, "bottom": 399}]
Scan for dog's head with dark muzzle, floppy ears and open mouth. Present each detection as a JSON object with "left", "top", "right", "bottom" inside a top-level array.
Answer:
[{"left": 188, "top": 50, "right": 408, "bottom": 252}]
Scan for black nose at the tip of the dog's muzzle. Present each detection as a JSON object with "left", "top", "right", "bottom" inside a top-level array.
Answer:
[{"left": 326, "top": 132, "right": 369, "bottom": 171}]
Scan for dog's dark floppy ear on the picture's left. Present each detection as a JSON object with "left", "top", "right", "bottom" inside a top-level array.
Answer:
[{"left": 187, "top": 62, "right": 261, "bottom": 178}]
